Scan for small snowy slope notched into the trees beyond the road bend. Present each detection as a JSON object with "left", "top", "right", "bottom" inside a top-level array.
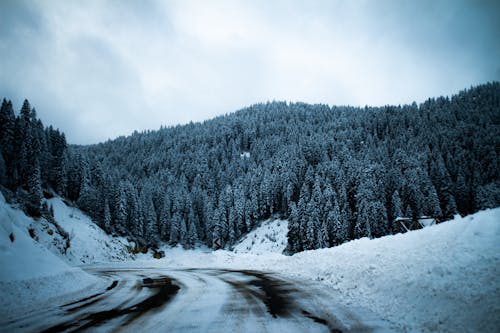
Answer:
[{"left": 233, "top": 220, "right": 288, "bottom": 254}]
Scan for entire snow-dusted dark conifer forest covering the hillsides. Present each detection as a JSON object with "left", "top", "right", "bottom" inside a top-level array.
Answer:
[{"left": 0, "top": 82, "right": 500, "bottom": 253}]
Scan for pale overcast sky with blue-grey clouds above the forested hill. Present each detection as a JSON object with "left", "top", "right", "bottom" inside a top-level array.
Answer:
[{"left": 0, "top": 0, "right": 500, "bottom": 144}]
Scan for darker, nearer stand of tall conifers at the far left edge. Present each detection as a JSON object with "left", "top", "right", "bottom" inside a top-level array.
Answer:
[{"left": 0, "top": 99, "right": 67, "bottom": 216}]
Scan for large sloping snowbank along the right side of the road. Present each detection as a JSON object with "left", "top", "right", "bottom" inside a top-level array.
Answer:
[{"left": 260, "top": 208, "right": 500, "bottom": 332}]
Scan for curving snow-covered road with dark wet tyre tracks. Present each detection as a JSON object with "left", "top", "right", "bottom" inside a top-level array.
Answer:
[{"left": 0, "top": 267, "right": 371, "bottom": 332}]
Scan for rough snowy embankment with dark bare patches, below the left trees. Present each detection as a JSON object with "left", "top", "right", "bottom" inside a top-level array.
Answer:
[{"left": 46, "top": 197, "right": 133, "bottom": 264}]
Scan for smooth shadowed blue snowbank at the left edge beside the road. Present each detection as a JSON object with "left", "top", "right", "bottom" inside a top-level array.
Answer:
[{"left": 0, "top": 193, "right": 98, "bottom": 315}]
